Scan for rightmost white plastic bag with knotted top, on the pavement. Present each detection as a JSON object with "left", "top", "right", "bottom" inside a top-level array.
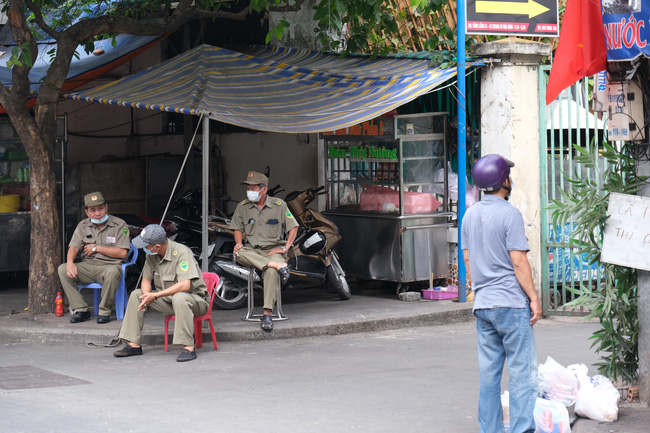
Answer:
[{"left": 567, "top": 364, "right": 621, "bottom": 422}]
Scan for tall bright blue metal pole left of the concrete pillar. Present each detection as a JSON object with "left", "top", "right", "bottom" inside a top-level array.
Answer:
[{"left": 456, "top": 0, "right": 467, "bottom": 302}]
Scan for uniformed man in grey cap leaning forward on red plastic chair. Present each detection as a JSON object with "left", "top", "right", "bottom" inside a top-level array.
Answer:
[{"left": 113, "top": 224, "right": 210, "bottom": 362}]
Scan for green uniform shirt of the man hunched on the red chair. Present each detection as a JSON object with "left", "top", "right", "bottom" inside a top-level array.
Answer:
[{"left": 142, "top": 240, "right": 209, "bottom": 301}]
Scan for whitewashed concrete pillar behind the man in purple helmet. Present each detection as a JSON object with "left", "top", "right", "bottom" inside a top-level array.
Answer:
[{"left": 472, "top": 38, "right": 551, "bottom": 290}]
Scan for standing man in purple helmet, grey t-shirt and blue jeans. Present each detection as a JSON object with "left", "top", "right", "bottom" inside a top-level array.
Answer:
[{"left": 461, "top": 154, "right": 542, "bottom": 433}]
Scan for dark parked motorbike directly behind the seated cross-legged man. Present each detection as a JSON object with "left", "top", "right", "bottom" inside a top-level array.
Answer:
[{"left": 210, "top": 186, "right": 351, "bottom": 309}]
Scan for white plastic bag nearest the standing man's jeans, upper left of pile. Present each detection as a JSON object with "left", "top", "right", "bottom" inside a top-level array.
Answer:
[{"left": 537, "top": 356, "right": 578, "bottom": 406}]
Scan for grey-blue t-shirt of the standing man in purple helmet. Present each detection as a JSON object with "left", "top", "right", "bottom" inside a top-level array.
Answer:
[{"left": 461, "top": 194, "right": 530, "bottom": 310}]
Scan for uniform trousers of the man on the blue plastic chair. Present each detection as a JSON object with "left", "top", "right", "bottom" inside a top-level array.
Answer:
[{"left": 59, "top": 262, "right": 122, "bottom": 316}]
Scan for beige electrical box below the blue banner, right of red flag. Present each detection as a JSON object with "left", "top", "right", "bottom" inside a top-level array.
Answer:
[{"left": 607, "top": 81, "right": 645, "bottom": 141}]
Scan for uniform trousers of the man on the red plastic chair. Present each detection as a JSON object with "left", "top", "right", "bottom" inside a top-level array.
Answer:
[{"left": 120, "top": 289, "right": 208, "bottom": 346}]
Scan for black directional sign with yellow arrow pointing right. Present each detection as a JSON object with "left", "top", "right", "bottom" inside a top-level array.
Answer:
[{"left": 465, "top": 0, "right": 560, "bottom": 37}]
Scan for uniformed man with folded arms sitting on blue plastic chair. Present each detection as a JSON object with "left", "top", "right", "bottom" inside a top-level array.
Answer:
[{"left": 59, "top": 191, "right": 130, "bottom": 323}]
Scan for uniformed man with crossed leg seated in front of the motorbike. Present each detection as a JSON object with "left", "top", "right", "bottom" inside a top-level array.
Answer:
[{"left": 230, "top": 171, "right": 298, "bottom": 331}]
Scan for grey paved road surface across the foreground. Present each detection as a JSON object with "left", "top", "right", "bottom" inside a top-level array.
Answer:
[{"left": 0, "top": 319, "right": 597, "bottom": 433}]
